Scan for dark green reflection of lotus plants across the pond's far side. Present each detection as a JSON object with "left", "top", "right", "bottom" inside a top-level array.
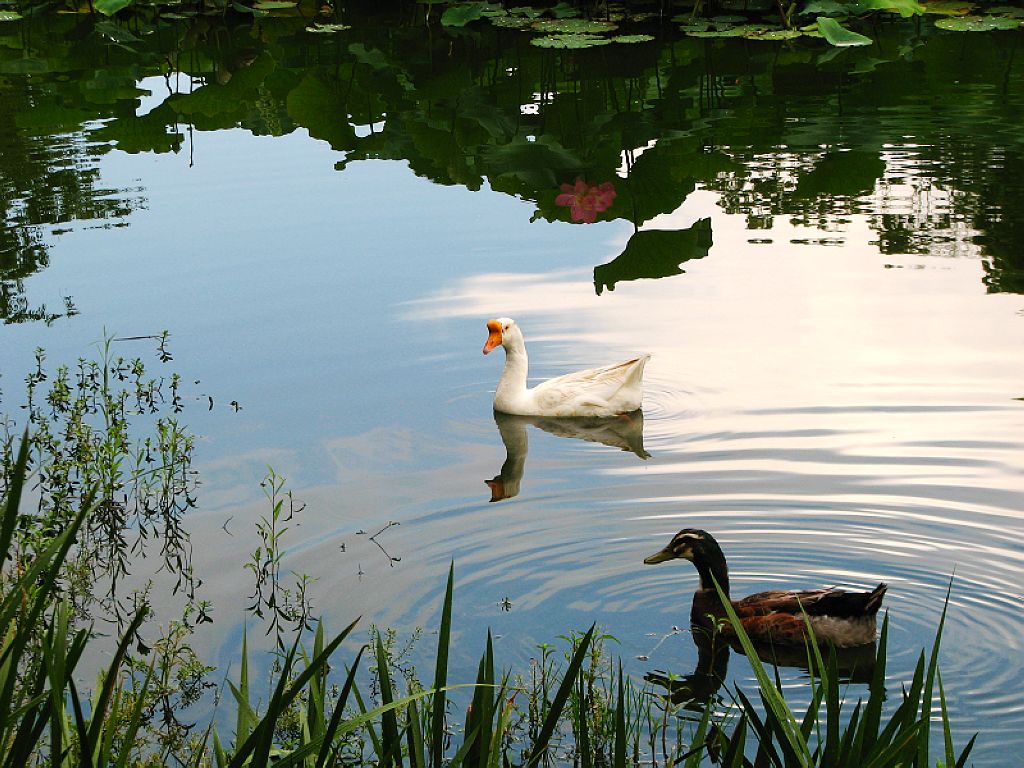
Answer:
[{"left": 0, "top": 12, "right": 1024, "bottom": 322}]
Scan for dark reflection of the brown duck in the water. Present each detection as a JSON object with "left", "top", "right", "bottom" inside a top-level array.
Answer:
[{"left": 644, "top": 627, "right": 878, "bottom": 711}]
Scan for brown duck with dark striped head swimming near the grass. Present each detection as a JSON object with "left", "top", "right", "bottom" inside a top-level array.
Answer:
[{"left": 644, "top": 528, "right": 886, "bottom": 648}]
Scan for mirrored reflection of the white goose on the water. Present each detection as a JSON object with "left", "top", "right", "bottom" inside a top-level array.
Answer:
[{"left": 484, "top": 410, "right": 650, "bottom": 502}]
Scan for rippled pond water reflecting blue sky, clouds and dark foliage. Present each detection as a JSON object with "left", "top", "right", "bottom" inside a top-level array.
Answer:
[{"left": 0, "top": 9, "right": 1024, "bottom": 765}]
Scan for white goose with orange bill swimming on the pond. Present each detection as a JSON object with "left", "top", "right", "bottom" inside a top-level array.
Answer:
[{"left": 483, "top": 317, "right": 650, "bottom": 418}]
